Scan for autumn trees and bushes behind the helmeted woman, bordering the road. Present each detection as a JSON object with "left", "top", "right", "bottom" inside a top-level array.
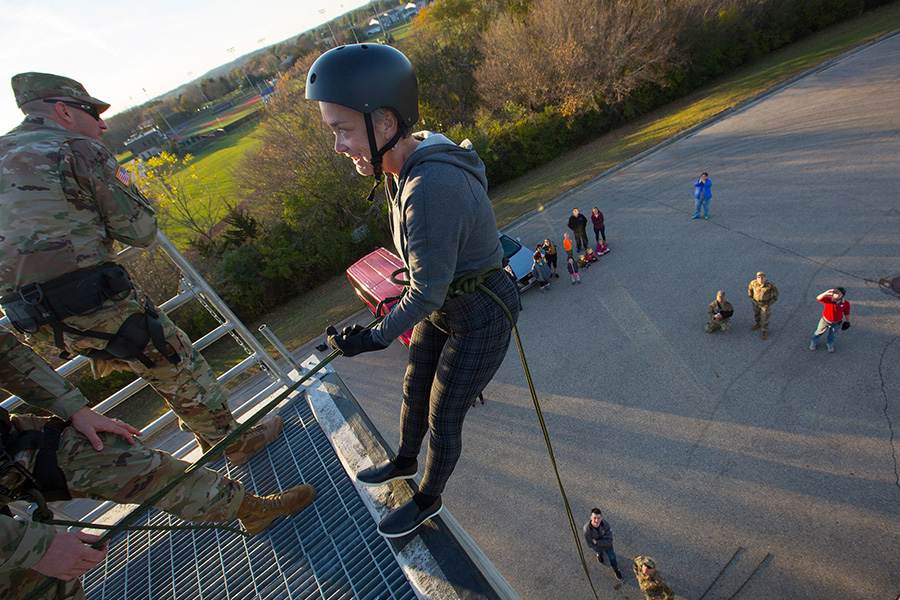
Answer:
[{"left": 134, "top": 0, "right": 883, "bottom": 342}]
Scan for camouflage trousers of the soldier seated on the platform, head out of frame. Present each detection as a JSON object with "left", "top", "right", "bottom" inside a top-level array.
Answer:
[{"left": 0, "top": 415, "right": 244, "bottom": 600}]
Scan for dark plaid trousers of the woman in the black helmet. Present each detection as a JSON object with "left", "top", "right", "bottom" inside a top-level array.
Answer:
[{"left": 398, "top": 271, "right": 519, "bottom": 496}]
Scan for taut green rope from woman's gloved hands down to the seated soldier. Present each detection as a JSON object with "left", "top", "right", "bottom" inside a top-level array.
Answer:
[{"left": 25, "top": 324, "right": 374, "bottom": 600}]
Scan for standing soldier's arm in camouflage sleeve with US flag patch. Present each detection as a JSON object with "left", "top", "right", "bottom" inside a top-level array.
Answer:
[{"left": 60, "top": 140, "right": 159, "bottom": 248}]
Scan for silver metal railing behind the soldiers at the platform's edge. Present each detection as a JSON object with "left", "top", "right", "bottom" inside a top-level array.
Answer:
[{"left": 0, "top": 231, "right": 302, "bottom": 435}]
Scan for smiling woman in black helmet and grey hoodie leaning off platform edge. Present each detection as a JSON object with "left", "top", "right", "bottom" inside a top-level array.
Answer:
[{"left": 306, "top": 44, "right": 519, "bottom": 537}]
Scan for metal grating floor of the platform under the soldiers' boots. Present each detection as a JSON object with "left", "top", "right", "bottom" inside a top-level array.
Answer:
[{"left": 84, "top": 396, "right": 416, "bottom": 600}]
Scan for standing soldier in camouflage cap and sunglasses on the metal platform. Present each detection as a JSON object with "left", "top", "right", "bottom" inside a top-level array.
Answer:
[{"left": 0, "top": 73, "right": 282, "bottom": 464}]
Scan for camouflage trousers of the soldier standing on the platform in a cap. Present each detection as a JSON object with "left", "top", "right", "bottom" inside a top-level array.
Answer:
[{"left": 28, "top": 290, "right": 235, "bottom": 443}]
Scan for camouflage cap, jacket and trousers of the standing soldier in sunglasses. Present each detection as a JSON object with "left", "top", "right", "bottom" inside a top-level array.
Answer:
[{"left": 0, "top": 73, "right": 235, "bottom": 443}]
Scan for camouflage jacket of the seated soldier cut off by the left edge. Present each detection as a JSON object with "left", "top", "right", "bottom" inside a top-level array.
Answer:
[{"left": 0, "top": 328, "right": 87, "bottom": 572}]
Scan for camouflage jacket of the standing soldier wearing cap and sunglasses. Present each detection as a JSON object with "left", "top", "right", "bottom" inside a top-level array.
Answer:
[{"left": 0, "top": 115, "right": 157, "bottom": 295}]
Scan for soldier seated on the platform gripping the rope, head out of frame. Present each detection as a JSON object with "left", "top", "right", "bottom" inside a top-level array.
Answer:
[{"left": 0, "top": 331, "right": 315, "bottom": 600}]
